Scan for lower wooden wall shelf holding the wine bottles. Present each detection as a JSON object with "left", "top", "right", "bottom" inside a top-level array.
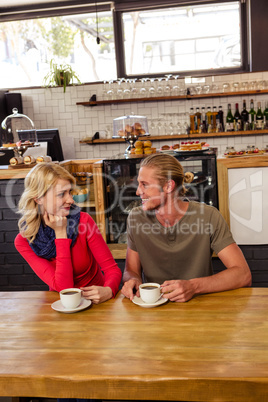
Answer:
[{"left": 79, "top": 129, "right": 268, "bottom": 145}]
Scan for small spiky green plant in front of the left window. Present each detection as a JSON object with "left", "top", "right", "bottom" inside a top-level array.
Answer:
[{"left": 44, "top": 60, "right": 81, "bottom": 92}]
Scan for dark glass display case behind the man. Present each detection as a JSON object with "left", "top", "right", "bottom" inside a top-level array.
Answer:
[{"left": 103, "top": 150, "right": 218, "bottom": 243}]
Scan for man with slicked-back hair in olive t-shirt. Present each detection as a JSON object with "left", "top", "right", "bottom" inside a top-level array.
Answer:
[{"left": 122, "top": 154, "right": 251, "bottom": 302}]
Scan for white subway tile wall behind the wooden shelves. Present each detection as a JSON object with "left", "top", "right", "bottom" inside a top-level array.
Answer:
[{"left": 9, "top": 71, "right": 268, "bottom": 159}]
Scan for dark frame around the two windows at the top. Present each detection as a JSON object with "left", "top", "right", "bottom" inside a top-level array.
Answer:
[{"left": 0, "top": 0, "right": 252, "bottom": 87}]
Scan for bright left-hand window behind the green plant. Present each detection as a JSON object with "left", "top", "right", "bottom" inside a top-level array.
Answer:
[{"left": 0, "top": 11, "right": 116, "bottom": 88}]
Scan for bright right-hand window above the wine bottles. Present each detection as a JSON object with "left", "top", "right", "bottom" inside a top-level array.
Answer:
[{"left": 122, "top": 1, "right": 242, "bottom": 76}]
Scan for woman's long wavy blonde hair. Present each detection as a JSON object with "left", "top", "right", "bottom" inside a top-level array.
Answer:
[{"left": 18, "top": 163, "right": 75, "bottom": 243}]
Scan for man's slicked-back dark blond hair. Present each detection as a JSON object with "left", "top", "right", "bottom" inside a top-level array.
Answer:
[{"left": 140, "top": 154, "right": 187, "bottom": 196}]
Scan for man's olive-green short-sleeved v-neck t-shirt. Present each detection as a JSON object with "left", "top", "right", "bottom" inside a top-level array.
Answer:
[{"left": 127, "top": 201, "right": 234, "bottom": 284}]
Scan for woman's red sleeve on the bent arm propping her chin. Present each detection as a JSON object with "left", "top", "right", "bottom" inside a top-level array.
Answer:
[{"left": 15, "top": 234, "right": 74, "bottom": 292}]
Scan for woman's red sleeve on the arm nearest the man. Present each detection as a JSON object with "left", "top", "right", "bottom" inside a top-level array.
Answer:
[{"left": 87, "top": 215, "right": 122, "bottom": 296}]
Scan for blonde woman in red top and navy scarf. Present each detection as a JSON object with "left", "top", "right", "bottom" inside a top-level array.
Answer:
[{"left": 15, "top": 163, "right": 122, "bottom": 304}]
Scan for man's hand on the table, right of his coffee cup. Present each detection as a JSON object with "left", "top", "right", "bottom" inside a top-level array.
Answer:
[{"left": 161, "top": 280, "right": 195, "bottom": 302}]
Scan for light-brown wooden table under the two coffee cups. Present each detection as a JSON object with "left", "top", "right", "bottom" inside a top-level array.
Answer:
[{"left": 0, "top": 288, "right": 268, "bottom": 402}]
